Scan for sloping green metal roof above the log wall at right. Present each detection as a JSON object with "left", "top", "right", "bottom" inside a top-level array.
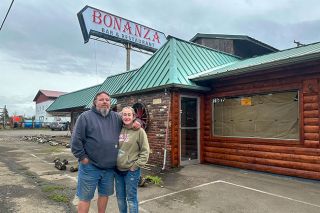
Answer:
[{"left": 189, "top": 42, "right": 320, "bottom": 81}]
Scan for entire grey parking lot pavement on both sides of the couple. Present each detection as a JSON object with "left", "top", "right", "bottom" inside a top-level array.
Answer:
[{"left": 0, "top": 131, "right": 320, "bottom": 213}]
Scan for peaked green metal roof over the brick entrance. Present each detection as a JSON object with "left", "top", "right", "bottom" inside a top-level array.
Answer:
[{"left": 114, "top": 36, "right": 239, "bottom": 97}]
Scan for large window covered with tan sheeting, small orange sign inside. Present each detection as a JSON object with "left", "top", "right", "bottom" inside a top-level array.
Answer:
[{"left": 212, "top": 91, "right": 299, "bottom": 139}]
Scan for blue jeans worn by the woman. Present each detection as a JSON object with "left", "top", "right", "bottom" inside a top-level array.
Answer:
[{"left": 115, "top": 168, "right": 141, "bottom": 213}]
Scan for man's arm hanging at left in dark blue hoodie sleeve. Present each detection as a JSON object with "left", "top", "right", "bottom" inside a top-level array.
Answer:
[{"left": 71, "top": 115, "right": 88, "bottom": 161}]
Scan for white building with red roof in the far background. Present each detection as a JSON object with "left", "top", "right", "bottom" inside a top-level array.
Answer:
[{"left": 33, "top": 90, "right": 70, "bottom": 125}]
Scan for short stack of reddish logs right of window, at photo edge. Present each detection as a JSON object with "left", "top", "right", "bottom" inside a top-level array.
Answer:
[{"left": 301, "top": 79, "right": 320, "bottom": 148}]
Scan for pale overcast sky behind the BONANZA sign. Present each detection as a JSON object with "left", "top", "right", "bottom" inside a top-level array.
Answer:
[{"left": 0, "top": 0, "right": 320, "bottom": 116}]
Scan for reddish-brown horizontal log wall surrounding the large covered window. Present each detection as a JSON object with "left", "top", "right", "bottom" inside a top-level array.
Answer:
[{"left": 201, "top": 65, "right": 320, "bottom": 180}]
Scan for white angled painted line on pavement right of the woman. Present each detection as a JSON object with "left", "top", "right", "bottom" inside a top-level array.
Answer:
[{"left": 139, "top": 180, "right": 320, "bottom": 208}]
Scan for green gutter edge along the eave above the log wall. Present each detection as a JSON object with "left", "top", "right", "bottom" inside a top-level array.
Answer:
[{"left": 189, "top": 52, "right": 320, "bottom": 81}]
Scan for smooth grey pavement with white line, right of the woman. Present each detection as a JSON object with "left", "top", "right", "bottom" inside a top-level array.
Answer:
[{"left": 140, "top": 165, "right": 320, "bottom": 213}]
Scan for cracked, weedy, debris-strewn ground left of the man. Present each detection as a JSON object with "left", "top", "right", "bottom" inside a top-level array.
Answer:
[{"left": 0, "top": 130, "right": 76, "bottom": 213}]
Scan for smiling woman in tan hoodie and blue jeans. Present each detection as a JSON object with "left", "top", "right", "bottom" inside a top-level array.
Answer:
[{"left": 116, "top": 107, "right": 150, "bottom": 213}]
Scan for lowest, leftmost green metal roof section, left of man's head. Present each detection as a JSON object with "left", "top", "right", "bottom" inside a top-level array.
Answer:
[{"left": 46, "top": 84, "right": 101, "bottom": 112}]
